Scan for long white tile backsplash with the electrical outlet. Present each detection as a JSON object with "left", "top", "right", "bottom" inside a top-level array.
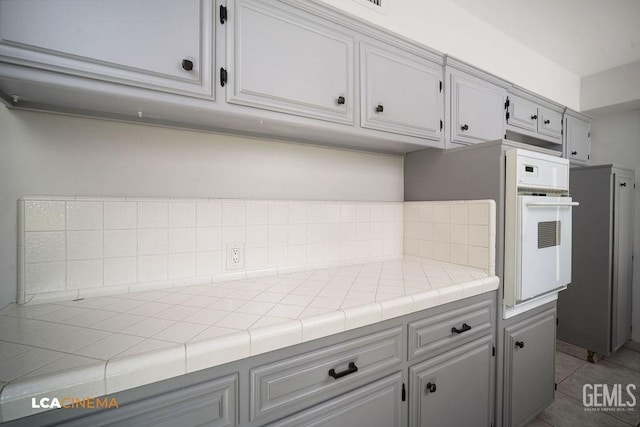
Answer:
[{"left": 18, "top": 196, "right": 403, "bottom": 302}]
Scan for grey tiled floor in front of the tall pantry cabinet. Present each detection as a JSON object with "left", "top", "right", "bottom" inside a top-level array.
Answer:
[{"left": 527, "top": 341, "right": 640, "bottom": 427}]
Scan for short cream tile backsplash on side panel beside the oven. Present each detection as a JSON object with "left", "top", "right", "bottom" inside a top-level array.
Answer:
[{"left": 404, "top": 200, "right": 496, "bottom": 275}]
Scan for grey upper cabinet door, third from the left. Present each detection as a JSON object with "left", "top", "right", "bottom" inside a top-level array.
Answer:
[{"left": 360, "top": 43, "right": 443, "bottom": 140}]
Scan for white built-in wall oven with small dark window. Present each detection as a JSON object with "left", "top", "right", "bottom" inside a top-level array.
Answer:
[{"left": 503, "top": 149, "right": 578, "bottom": 318}]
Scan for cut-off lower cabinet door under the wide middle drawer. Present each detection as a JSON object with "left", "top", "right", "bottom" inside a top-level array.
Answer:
[{"left": 270, "top": 372, "right": 403, "bottom": 427}]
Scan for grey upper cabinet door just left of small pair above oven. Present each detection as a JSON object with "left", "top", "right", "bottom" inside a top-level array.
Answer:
[{"left": 450, "top": 73, "right": 507, "bottom": 144}]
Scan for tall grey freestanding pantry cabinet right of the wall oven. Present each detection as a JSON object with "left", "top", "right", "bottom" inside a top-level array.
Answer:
[{"left": 557, "top": 165, "right": 635, "bottom": 361}]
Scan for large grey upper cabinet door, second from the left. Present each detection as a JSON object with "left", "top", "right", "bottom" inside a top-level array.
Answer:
[{"left": 227, "top": 0, "right": 354, "bottom": 124}]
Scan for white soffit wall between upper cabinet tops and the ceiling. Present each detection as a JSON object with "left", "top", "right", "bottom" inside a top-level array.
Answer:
[{"left": 321, "top": 0, "right": 580, "bottom": 111}]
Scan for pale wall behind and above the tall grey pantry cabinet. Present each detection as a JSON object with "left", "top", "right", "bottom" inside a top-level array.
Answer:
[{"left": 591, "top": 109, "right": 640, "bottom": 341}]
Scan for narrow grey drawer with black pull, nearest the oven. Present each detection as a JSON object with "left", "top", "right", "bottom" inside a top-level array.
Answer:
[{"left": 408, "top": 301, "right": 493, "bottom": 360}]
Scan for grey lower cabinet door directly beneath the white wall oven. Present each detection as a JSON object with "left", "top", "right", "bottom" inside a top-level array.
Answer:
[{"left": 504, "top": 309, "right": 556, "bottom": 426}]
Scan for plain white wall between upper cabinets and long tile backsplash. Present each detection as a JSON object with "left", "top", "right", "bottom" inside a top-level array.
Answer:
[{"left": 0, "top": 106, "right": 404, "bottom": 308}]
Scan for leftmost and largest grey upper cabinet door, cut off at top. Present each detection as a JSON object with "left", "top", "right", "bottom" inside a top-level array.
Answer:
[{"left": 0, "top": 0, "right": 214, "bottom": 98}]
